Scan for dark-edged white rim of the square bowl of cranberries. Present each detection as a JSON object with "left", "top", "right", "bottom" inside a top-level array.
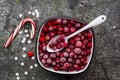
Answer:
[{"left": 36, "top": 16, "right": 94, "bottom": 74}]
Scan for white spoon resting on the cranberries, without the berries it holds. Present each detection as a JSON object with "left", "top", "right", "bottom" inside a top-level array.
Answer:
[{"left": 47, "top": 15, "right": 106, "bottom": 52}]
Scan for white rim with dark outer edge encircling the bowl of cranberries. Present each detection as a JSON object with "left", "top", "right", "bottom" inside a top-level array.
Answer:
[{"left": 35, "top": 15, "right": 95, "bottom": 74}]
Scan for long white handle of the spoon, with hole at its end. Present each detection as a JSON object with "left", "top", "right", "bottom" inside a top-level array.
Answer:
[{"left": 66, "top": 15, "right": 106, "bottom": 39}]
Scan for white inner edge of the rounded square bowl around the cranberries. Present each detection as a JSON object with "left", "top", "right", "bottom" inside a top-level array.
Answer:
[{"left": 37, "top": 18, "right": 94, "bottom": 74}]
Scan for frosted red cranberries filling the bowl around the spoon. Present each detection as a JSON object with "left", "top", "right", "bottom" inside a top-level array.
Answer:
[{"left": 38, "top": 18, "right": 92, "bottom": 71}]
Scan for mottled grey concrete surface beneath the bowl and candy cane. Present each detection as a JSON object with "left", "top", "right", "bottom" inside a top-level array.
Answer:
[{"left": 0, "top": 0, "right": 120, "bottom": 80}]
